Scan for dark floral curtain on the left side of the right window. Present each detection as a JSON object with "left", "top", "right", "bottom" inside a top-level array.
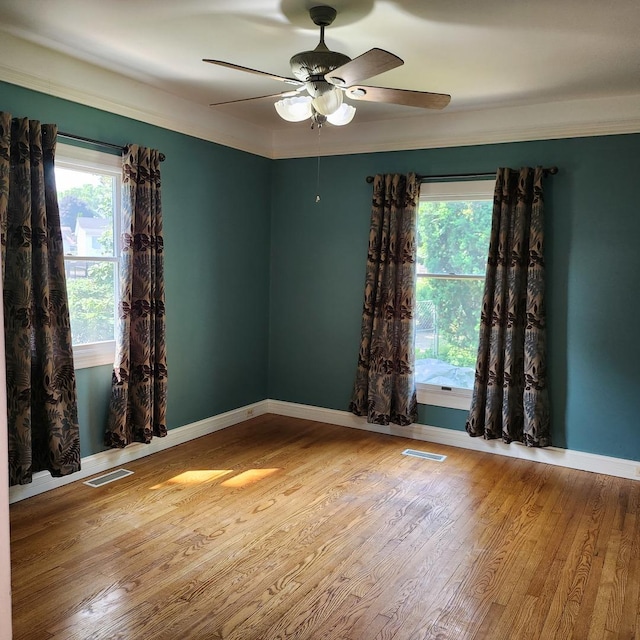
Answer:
[{"left": 349, "top": 174, "right": 420, "bottom": 425}]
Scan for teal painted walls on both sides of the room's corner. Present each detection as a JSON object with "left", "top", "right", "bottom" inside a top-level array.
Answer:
[{"left": 0, "top": 83, "right": 640, "bottom": 460}]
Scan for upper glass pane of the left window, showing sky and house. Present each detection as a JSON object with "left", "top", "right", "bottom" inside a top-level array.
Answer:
[{"left": 56, "top": 167, "right": 115, "bottom": 256}]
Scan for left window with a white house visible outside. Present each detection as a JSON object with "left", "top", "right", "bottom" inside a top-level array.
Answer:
[{"left": 56, "top": 145, "right": 122, "bottom": 369}]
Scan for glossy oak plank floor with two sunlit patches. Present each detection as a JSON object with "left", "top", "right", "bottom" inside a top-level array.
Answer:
[{"left": 11, "top": 416, "right": 640, "bottom": 640}]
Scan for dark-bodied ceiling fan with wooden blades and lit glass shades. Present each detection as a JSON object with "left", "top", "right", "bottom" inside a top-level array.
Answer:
[{"left": 203, "top": 6, "right": 451, "bottom": 128}]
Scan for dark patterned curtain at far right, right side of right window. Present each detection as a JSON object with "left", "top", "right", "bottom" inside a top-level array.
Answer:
[{"left": 466, "top": 167, "right": 551, "bottom": 447}]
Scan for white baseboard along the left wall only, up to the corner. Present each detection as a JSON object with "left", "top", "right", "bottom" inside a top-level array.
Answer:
[{"left": 9, "top": 400, "right": 268, "bottom": 504}]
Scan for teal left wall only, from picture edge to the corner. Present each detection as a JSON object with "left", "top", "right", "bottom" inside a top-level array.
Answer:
[{"left": 0, "top": 83, "right": 273, "bottom": 456}]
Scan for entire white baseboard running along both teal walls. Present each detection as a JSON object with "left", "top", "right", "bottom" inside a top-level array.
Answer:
[{"left": 9, "top": 400, "right": 640, "bottom": 503}]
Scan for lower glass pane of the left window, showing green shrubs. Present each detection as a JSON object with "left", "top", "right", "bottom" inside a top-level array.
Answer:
[{"left": 65, "top": 260, "right": 117, "bottom": 345}]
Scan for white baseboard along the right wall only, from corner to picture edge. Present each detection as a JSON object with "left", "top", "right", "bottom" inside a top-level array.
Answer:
[{"left": 267, "top": 400, "right": 640, "bottom": 480}]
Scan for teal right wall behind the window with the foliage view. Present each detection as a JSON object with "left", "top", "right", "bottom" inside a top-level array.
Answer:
[{"left": 269, "top": 135, "right": 640, "bottom": 460}]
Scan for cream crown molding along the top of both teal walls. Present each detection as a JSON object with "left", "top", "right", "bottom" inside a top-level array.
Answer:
[{"left": 0, "top": 33, "right": 640, "bottom": 159}]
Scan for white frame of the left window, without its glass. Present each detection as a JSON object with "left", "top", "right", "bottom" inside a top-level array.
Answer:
[{"left": 55, "top": 143, "right": 122, "bottom": 369}]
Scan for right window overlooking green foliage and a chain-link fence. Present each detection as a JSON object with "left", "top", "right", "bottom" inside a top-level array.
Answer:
[{"left": 415, "top": 180, "right": 495, "bottom": 409}]
